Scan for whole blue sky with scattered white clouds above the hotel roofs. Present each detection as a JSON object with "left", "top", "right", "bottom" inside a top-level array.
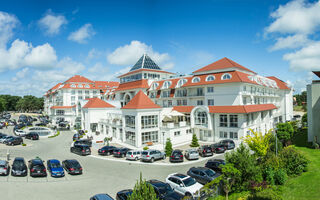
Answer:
[{"left": 0, "top": 0, "right": 320, "bottom": 96}]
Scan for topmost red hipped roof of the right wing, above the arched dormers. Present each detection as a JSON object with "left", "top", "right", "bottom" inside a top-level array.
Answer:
[{"left": 193, "top": 57, "right": 255, "bottom": 74}]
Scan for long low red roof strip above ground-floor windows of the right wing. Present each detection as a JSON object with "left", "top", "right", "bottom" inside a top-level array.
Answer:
[{"left": 208, "top": 104, "right": 277, "bottom": 113}]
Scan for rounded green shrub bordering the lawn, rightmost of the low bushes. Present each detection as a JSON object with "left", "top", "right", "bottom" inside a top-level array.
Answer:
[{"left": 280, "top": 146, "right": 308, "bottom": 176}]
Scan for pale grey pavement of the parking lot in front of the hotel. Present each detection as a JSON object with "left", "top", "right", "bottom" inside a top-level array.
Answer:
[{"left": 0, "top": 116, "right": 223, "bottom": 200}]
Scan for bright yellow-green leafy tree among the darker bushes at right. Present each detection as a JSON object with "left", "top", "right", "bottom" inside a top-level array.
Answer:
[{"left": 243, "top": 129, "right": 272, "bottom": 157}]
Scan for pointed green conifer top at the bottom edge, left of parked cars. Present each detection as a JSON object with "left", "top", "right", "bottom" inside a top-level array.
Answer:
[{"left": 128, "top": 173, "right": 158, "bottom": 200}]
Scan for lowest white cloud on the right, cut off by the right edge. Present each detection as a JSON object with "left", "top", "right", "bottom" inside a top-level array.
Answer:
[{"left": 283, "top": 41, "right": 320, "bottom": 71}]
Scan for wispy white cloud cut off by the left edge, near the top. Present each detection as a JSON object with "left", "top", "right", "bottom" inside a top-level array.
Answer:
[{"left": 0, "top": 11, "right": 19, "bottom": 48}]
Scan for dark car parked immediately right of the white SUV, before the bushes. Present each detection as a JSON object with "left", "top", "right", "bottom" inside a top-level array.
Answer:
[{"left": 187, "top": 167, "right": 220, "bottom": 185}]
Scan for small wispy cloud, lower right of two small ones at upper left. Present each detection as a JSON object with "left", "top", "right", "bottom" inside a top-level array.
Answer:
[{"left": 68, "top": 24, "right": 95, "bottom": 44}]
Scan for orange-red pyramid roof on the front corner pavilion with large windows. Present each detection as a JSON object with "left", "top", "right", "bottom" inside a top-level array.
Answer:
[{"left": 121, "top": 90, "right": 161, "bottom": 109}]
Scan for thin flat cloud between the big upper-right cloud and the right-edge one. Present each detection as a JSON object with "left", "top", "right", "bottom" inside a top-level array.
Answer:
[{"left": 269, "top": 34, "right": 311, "bottom": 51}]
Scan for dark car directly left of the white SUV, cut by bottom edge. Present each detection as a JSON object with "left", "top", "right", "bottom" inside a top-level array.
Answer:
[{"left": 147, "top": 179, "right": 184, "bottom": 200}]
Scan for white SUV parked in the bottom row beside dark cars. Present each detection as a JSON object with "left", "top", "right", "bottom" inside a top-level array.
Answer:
[{"left": 166, "top": 173, "right": 203, "bottom": 198}]
